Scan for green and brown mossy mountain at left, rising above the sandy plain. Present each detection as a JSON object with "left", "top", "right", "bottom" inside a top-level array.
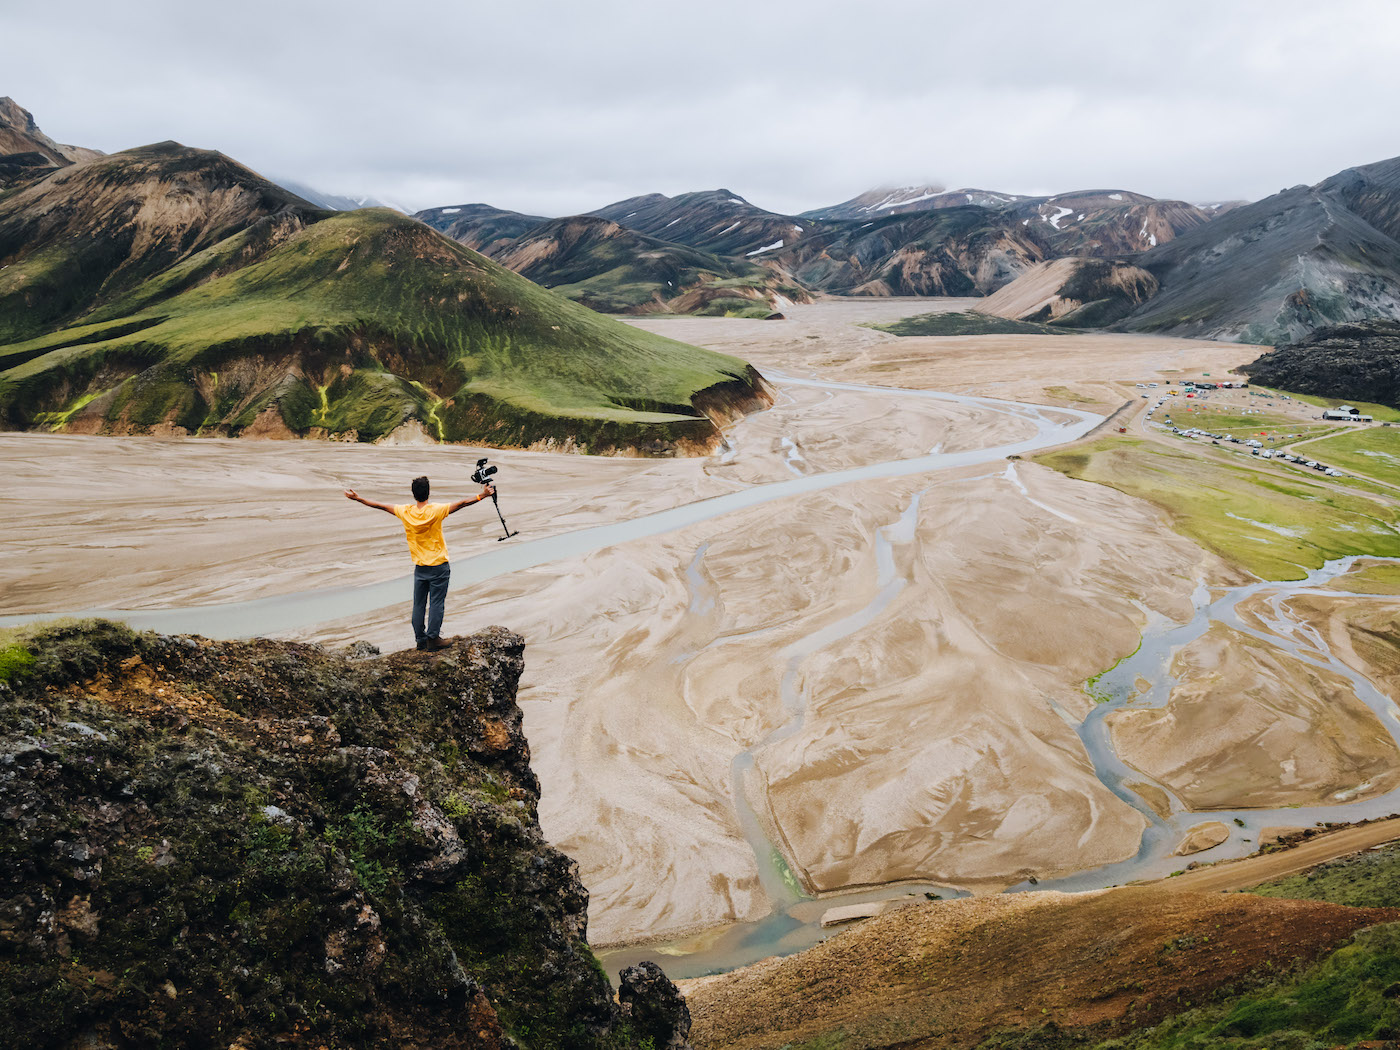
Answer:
[{"left": 0, "top": 143, "right": 770, "bottom": 454}]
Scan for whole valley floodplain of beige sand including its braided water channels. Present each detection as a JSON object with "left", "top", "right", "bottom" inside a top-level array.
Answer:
[{"left": 0, "top": 302, "right": 1400, "bottom": 976}]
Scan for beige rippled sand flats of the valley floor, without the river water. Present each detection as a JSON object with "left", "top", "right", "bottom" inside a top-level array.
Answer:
[{"left": 0, "top": 300, "right": 1377, "bottom": 944}]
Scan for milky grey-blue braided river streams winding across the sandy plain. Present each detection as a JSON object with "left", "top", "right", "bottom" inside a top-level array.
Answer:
[{"left": 10, "top": 377, "right": 1400, "bottom": 979}]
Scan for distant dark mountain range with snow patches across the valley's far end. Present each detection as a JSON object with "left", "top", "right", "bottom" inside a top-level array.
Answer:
[{"left": 417, "top": 186, "right": 1211, "bottom": 315}]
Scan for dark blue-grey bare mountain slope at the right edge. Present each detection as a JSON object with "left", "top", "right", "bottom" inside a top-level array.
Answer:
[{"left": 1124, "top": 158, "right": 1400, "bottom": 343}]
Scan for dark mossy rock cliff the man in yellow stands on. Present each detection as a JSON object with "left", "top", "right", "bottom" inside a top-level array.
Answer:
[{"left": 0, "top": 623, "right": 685, "bottom": 1050}]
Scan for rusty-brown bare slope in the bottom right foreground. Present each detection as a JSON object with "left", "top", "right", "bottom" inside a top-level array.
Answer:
[{"left": 686, "top": 888, "right": 1400, "bottom": 1050}]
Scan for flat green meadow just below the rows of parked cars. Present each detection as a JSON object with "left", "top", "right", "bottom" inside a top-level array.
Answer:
[{"left": 1036, "top": 435, "right": 1400, "bottom": 580}]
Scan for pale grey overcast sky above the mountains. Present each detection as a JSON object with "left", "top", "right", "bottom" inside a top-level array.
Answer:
[{"left": 10, "top": 0, "right": 1400, "bottom": 216}]
